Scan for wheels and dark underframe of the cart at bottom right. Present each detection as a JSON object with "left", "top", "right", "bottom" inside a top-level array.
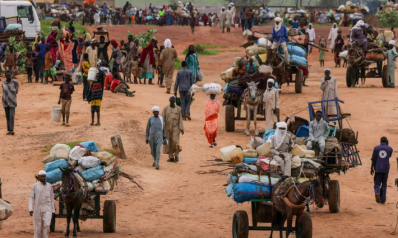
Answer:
[{"left": 232, "top": 199, "right": 312, "bottom": 238}]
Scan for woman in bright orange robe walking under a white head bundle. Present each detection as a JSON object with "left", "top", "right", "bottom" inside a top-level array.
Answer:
[{"left": 203, "top": 94, "right": 220, "bottom": 148}]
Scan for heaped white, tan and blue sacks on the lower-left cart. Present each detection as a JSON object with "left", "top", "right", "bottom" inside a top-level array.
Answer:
[{"left": 42, "top": 141, "right": 119, "bottom": 192}]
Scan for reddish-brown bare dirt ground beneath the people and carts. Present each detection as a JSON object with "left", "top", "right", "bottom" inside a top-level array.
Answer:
[{"left": 0, "top": 26, "right": 398, "bottom": 238}]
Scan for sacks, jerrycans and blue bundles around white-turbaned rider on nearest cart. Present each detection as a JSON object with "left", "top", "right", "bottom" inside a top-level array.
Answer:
[{"left": 224, "top": 133, "right": 322, "bottom": 203}]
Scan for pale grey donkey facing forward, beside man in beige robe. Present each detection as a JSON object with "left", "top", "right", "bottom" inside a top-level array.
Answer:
[{"left": 243, "top": 82, "right": 263, "bottom": 136}]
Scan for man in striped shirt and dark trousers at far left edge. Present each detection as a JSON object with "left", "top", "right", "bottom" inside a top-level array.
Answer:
[{"left": 2, "top": 71, "right": 19, "bottom": 135}]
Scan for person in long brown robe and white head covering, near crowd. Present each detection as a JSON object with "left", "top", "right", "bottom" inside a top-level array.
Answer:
[{"left": 159, "top": 39, "right": 178, "bottom": 93}]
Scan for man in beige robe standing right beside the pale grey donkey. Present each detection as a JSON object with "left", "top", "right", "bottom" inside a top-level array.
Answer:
[{"left": 263, "top": 75, "right": 279, "bottom": 130}]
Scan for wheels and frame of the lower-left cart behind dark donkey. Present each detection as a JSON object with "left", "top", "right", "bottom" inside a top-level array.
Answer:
[{"left": 50, "top": 192, "right": 116, "bottom": 233}]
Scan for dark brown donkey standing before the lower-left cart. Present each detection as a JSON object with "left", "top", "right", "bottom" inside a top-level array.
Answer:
[{"left": 60, "top": 168, "right": 87, "bottom": 238}]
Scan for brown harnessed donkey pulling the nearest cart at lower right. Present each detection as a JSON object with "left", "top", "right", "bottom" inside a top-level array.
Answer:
[{"left": 270, "top": 179, "right": 323, "bottom": 238}]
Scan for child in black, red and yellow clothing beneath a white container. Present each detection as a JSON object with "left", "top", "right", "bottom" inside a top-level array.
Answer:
[{"left": 87, "top": 73, "right": 104, "bottom": 126}]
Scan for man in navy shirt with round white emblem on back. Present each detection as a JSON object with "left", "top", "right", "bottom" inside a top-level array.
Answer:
[{"left": 370, "top": 137, "right": 393, "bottom": 204}]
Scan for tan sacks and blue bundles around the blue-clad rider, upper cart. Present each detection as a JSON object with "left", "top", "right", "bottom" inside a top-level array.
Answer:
[{"left": 220, "top": 30, "right": 308, "bottom": 83}]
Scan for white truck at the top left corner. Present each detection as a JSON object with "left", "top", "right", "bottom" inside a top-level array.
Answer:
[{"left": 0, "top": 1, "right": 41, "bottom": 41}]
